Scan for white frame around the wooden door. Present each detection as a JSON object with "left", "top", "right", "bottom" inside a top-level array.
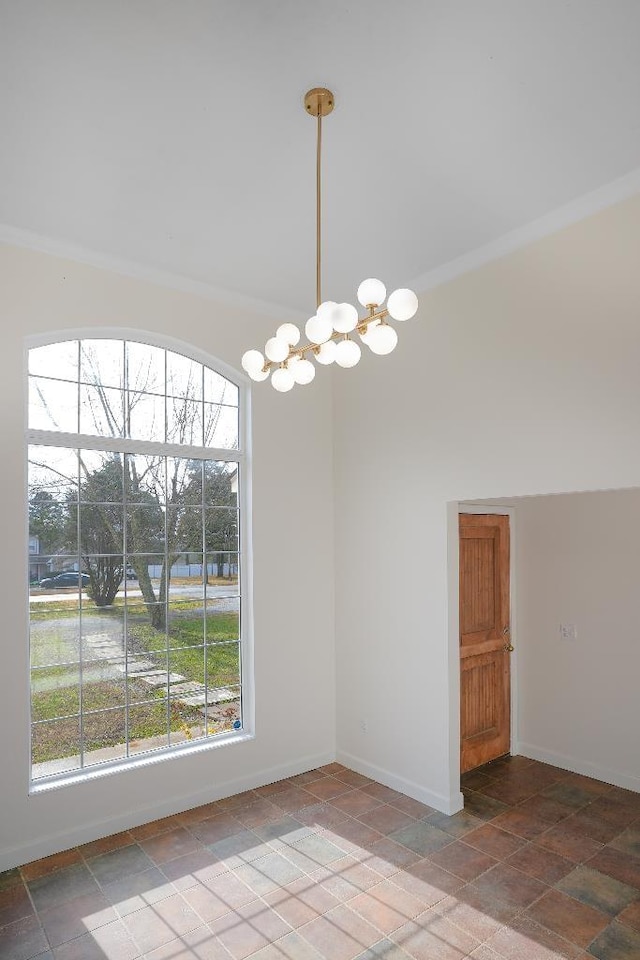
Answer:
[{"left": 447, "top": 500, "right": 519, "bottom": 797}]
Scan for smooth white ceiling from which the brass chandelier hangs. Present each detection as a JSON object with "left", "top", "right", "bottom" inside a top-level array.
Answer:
[{"left": 0, "top": 0, "right": 640, "bottom": 314}]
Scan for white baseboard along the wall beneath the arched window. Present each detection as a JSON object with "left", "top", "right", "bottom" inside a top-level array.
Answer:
[{"left": 0, "top": 753, "right": 335, "bottom": 871}]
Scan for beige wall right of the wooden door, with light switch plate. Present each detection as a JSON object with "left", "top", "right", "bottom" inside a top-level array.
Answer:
[{"left": 514, "top": 490, "right": 640, "bottom": 790}]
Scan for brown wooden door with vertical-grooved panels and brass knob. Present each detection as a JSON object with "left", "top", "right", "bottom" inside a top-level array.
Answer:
[{"left": 459, "top": 513, "right": 513, "bottom": 773}]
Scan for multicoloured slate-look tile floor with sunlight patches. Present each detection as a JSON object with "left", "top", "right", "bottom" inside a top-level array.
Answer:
[{"left": 0, "top": 757, "right": 640, "bottom": 960}]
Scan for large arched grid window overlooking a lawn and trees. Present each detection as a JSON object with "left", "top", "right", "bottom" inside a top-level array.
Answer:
[{"left": 28, "top": 338, "right": 245, "bottom": 781}]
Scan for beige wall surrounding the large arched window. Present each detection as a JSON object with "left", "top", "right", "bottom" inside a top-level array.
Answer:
[{"left": 0, "top": 246, "right": 335, "bottom": 870}]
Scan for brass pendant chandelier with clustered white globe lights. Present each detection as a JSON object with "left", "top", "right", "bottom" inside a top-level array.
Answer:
[{"left": 242, "top": 87, "right": 418, "bottom": 393}]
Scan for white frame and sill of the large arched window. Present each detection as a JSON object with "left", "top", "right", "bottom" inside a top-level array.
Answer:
[{"left": 23, "top": 327, "right": 255, "bottom": 794}]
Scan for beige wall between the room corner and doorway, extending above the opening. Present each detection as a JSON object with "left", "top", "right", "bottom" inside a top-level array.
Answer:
[{"left": 334, "top": 197, "right": 640, "bottom": 810}]
